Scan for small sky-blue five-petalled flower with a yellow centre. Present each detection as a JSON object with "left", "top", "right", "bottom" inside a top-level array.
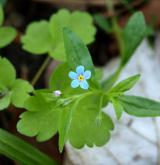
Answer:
[{"left": 69, "top": 65, "right": 91, "bottom": 89}]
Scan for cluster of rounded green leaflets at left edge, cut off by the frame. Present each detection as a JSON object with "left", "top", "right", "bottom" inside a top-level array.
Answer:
[{"left": 0, "top": 57, "right": 33, "bottom": 110}]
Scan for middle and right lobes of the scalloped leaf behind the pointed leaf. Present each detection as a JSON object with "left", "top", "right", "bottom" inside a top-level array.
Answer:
[{"left": 49, "top": 9, "right": 96, "bottom": 61}]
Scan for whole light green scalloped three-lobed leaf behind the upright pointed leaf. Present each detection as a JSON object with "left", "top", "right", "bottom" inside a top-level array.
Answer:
[{"left": 22, "top": 9, "right": 96, "bottom": 61}]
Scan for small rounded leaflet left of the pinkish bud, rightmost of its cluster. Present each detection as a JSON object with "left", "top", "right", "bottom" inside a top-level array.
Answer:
[{"left": 11, "top": 79, "right": 33, "bottom": 108}]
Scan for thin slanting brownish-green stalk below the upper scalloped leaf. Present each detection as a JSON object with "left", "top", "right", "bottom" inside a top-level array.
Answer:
[{"left": 31, "top": 56, "right": 50, "bottom": 86}]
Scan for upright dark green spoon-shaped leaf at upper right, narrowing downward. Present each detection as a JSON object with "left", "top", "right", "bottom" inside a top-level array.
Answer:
[{"left": 97, "top": 12, "right": 147, "bottom": 90}]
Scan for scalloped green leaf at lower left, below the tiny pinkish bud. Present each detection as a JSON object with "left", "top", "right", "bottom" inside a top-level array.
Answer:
[{"left": 17, "top": 95, "right": 61, "bottom": 142}]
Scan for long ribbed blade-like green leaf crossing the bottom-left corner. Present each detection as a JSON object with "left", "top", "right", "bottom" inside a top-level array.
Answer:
[{"left": 0, "top": 129, "right": 57, "bottom": 165}]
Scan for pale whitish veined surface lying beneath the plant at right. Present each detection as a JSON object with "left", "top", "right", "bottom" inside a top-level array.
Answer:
[{"left": 64, "top": 38, "right": 160, "bottom": 165}]
